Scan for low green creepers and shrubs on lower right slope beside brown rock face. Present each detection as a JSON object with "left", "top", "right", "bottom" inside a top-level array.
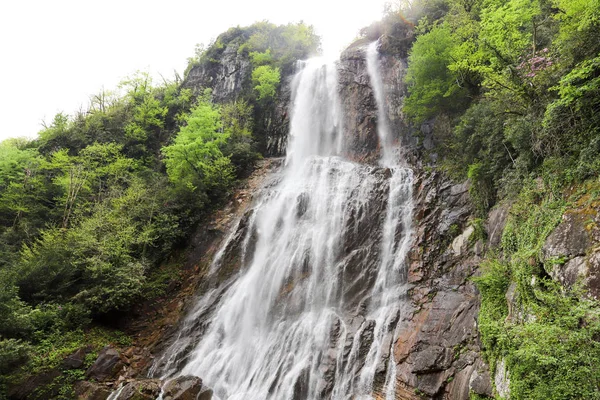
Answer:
[{"left": 474, "top": 180, "right": 600, "bottom": 400}]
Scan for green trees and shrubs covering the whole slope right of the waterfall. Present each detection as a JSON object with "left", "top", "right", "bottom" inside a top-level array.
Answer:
[{"left": 392, "top": 0, "right": 600, "bottom": 399}]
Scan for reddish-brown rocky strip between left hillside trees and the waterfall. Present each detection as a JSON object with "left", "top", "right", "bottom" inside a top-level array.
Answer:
[{"left": 138, "top": 158, "right": 283, "bottom": 374}]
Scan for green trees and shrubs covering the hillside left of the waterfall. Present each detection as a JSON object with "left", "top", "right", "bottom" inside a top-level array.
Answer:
[{"left": 0, "top": 22, "right": 318, "bottom": 398}]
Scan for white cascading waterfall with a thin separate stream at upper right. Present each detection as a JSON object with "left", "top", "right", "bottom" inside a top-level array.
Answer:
[{"left": 152, "top": 47, "right": 412, "bottom": 400}]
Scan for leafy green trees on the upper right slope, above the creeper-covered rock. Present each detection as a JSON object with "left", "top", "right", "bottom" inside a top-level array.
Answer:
[{"left": 404, "top": 0, "right": 600, "bottom": 215}]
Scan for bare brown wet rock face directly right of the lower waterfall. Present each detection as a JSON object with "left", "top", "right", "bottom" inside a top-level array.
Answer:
[{"left": 394, "top": 172, "right": 492, "bottom": 399}]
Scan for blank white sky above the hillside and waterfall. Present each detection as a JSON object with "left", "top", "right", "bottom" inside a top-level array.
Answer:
[{"left": 0, "top": 0, "right": 385, "bottom": 140}]
